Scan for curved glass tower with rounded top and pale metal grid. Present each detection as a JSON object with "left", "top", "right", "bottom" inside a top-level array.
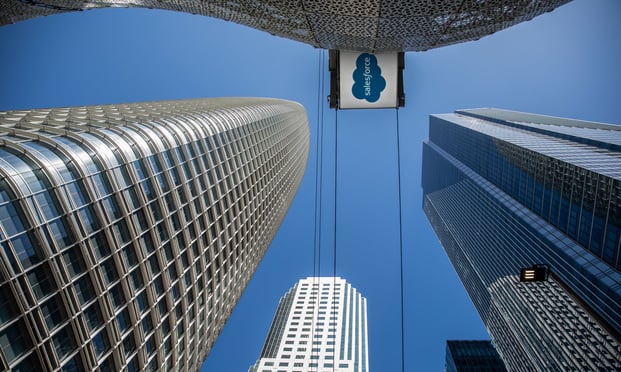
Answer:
[{"left": 0, "top": 99, "right": 309, "bottom": 371}]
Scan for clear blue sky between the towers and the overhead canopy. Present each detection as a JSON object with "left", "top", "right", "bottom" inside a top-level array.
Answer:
[{"left": 0, "top": 0, "right": 621, "bottom": 371}]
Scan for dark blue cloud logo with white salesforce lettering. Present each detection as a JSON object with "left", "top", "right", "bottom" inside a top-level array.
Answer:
[{"left": 351, "top": 53, "right": 386, "bottom": 102}]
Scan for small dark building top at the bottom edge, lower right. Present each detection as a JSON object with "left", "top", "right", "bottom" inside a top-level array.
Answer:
[{"left": 444, "top": 340, "right": 507, "bottom": 372}]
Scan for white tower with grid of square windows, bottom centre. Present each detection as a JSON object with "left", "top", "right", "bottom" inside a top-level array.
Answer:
[{"left": 249, "top": 277, "right": 369, "bottom": 372}]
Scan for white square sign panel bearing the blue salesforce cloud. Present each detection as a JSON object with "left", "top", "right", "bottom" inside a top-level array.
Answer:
[{"left": 338, "top": 51, "right": 401, "bottom": 109}]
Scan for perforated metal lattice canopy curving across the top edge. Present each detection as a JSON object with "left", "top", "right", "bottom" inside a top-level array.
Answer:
[{"left": 0, "top": 0, "right": 569, "bottom": 52}]
